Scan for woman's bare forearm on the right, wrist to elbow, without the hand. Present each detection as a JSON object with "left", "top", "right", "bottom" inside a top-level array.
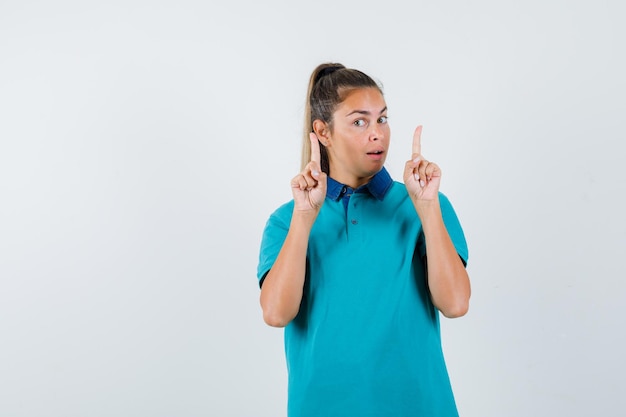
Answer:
[{"left": 418, "top": 200, "right": 471, "bottom": 318}]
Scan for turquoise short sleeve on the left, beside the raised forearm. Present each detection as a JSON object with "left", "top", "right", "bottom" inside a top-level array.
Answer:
[{"left": 257, "top": 202, "right": 293, "bottom": 287}]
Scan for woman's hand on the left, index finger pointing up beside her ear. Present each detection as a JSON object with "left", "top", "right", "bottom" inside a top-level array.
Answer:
[{"left": 291, "top": 132, "right": 326, "bottom": 214}]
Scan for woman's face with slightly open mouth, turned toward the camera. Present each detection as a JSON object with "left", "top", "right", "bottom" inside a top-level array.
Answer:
[{"left": 318, "top": 88, "right": 390, "bottom": 188}]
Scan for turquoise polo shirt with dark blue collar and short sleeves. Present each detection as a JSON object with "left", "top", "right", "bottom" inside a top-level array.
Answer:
[{"left": 257, "top": 168, "right": 468, "bottom": 417}]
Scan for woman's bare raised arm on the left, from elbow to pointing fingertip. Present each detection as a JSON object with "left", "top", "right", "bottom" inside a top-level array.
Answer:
[{"left": 261, "top": 133, "right": 326, "bottom": 327}]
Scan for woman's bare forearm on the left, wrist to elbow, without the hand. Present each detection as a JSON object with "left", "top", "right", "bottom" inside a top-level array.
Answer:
[{"left": 261, "top": 212, "right": 315, "bottom": 327}]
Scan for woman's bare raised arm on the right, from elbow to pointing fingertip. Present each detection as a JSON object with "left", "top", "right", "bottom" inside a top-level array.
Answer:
[{"left": 404, "top": 126, "right": 471, "bottom": 318}]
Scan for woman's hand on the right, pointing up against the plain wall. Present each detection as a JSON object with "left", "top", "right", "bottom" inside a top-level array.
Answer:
[{"left": 404, "top": 125, "right": 441, "bottom": 203}]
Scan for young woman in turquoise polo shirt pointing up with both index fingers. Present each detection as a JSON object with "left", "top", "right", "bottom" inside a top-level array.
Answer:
[{"left": 258, "top": 63, "right": 470, "bottom": 417}]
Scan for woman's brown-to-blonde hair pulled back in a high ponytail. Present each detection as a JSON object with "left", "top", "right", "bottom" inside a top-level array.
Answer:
[{"left": 300, "top": 63, "right": 382, "bottom": 174}]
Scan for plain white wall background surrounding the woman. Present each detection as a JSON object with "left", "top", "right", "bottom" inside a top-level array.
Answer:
[{"left": 0, "top": 0, "right": 626, "bottom": 417}]
